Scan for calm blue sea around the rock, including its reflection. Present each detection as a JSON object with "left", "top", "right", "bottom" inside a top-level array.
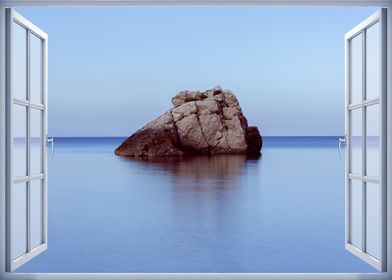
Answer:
[{"left": 18, "top": 137, "right": 375, "bottom": 272}]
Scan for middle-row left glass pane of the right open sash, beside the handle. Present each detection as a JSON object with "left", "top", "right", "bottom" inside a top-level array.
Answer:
[{"left": 350, "top": 109, "right": 362, "bottom": 175}]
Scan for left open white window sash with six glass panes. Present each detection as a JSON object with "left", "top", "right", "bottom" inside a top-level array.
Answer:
[{"left": 6, "top": 9, "right": 47, "bottom": 271}]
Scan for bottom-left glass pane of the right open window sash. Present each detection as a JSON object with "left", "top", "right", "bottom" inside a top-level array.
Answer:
[{"left": 350, "top": 180, "right": 362, "bottom": 249}]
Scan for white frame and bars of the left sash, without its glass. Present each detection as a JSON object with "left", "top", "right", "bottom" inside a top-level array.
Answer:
[{"left": 6, "top": 9, "right": 48, "bottom": 271}]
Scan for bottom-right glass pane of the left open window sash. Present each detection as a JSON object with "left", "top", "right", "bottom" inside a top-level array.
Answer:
[{"left": 30, "top": 180, "right": 43, "bottom": 249}]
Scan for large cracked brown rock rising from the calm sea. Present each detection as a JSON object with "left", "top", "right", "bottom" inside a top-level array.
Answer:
[{"left": 115, "top": 86, "right": 262, "bottom": 156}]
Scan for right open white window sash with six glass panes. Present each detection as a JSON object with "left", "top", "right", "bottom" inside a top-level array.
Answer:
[{"left": 345, "top": 9, "right": 387, "bottom": 271}]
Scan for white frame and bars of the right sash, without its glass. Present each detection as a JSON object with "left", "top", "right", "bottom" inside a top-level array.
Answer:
[{"left": 345, "top": 9, "right": 387, "bottom": 271}]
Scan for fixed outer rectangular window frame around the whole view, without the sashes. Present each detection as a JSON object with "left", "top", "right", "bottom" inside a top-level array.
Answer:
[{"left": 0, "top": 0, "right": 392, "bottom": 280}]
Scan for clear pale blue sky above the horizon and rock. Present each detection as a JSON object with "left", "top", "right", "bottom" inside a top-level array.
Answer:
[{"left": 16, "top": 7, "right": 377, "bottom": 136}]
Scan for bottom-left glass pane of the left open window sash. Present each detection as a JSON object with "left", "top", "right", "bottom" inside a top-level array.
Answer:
[{"left": 11, "top": 182, "right": 27, "bottom": 259}]
